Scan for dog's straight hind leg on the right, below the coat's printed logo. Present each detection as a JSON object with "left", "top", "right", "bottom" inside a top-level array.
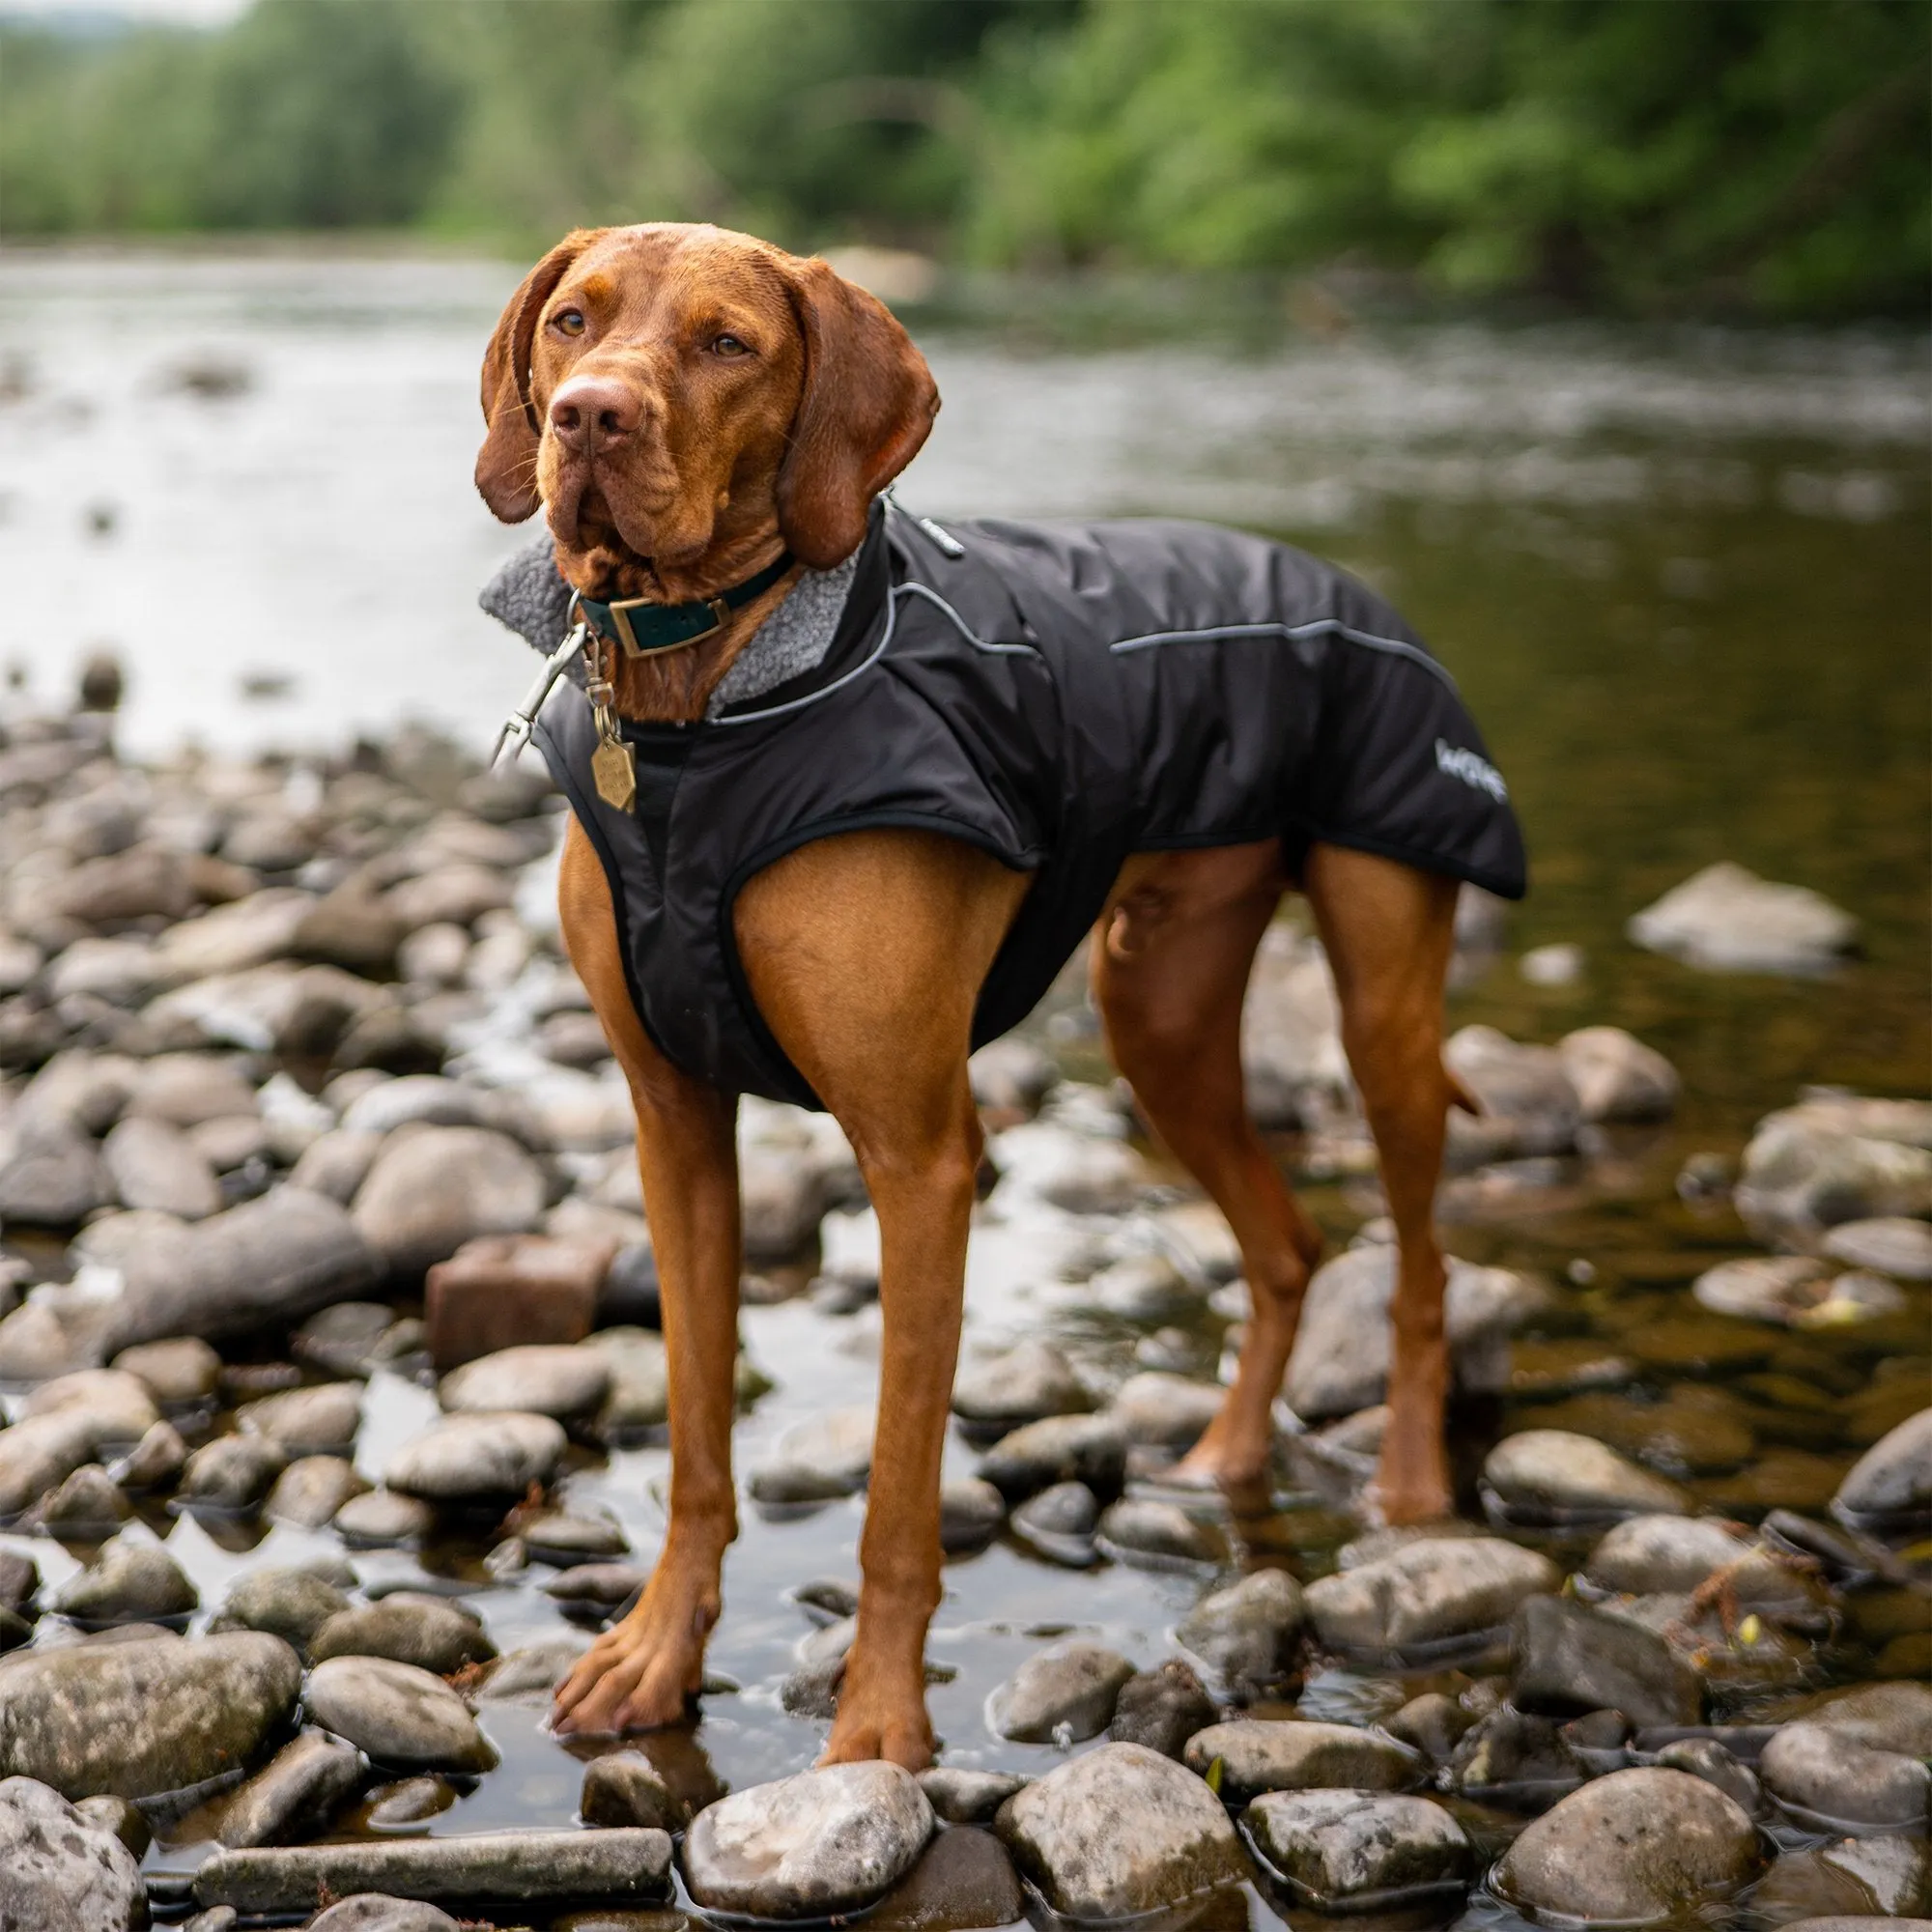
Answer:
[{"left": 1304, "top": 844, "right": 1457, "bottom": 1522}]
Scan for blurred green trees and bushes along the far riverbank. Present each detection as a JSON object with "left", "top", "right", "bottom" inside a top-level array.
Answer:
[{"left": 0, "top": 0, "right": 1932, "bottom": 313}]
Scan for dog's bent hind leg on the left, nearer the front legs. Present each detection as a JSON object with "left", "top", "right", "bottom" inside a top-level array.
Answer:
[{"left": 1092, "top": 840, "right": 1321, "bottom": 1488}]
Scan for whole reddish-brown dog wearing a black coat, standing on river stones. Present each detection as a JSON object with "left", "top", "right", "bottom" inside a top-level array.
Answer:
[{"left": 477, "top": 224, "right": 1520, "bottom": 1768}]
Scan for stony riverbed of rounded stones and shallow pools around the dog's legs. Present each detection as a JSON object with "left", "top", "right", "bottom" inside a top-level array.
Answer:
[{"left": 0, "top": 715, "right": 1932, "bottom": 1932}]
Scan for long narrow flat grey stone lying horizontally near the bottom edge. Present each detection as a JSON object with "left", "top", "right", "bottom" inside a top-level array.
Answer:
[{"left": 195, "top": 1832, "right": 670, "bottom": 1932}]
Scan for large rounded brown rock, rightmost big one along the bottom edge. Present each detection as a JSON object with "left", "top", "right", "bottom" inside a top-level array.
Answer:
[{"left": 1495, "top": 1768, "right": 1758, "bottom": 1924}]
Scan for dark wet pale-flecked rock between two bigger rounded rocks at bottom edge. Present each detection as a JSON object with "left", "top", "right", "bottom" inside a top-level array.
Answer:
[{"left": 1242, "top": 1791, "right": 1476, "bottom": 1911}]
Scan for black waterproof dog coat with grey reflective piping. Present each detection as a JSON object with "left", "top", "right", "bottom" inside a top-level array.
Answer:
[{"left": 495, "top": 502, "right": 1524, "bottom": 1107}]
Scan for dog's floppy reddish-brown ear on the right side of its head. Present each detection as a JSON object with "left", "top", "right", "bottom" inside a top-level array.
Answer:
[{"left": 777, "top": 259, "right": 939, "bottom": 570}]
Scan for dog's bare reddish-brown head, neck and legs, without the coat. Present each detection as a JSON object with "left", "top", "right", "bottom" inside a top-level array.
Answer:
[{"left": 477, "top": 224, "right": 1484, "bottom": 1768}]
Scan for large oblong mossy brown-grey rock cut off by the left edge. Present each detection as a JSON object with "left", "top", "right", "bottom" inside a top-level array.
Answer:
[{"left": 0, "top": 1631, "right": 301, "bottom": 1799}]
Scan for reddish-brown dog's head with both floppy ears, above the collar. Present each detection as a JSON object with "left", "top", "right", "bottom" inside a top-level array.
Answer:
[{"left": 477, "top": 222, "right": 939, "bottom": 593}]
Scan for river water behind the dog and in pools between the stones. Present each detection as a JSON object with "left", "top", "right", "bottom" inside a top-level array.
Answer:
[{"left": 0, "top": 253, "right": 1932, "bottom": 1926}]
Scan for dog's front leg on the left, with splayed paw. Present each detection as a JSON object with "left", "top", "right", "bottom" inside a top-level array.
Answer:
[{"left": 553, "top": 823, "right": 742, "bottom": 1731}]
